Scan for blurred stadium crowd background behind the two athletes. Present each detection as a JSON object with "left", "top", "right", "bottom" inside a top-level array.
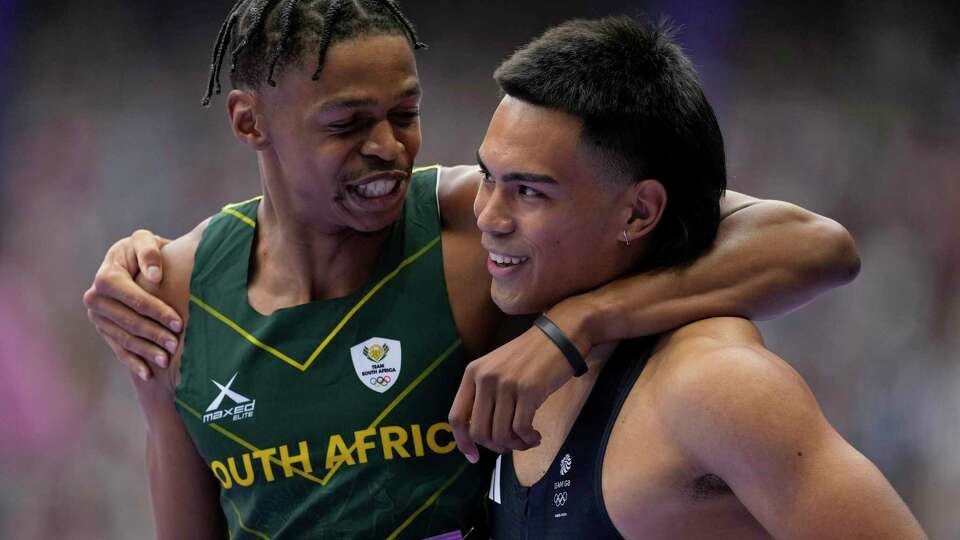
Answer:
[{"left": 0, "top": 0, "right": 960, "bottom": 539}]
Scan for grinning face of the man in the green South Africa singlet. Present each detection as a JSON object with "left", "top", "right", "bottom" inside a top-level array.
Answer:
[{"left": 249, "top": 35, "right": 420, "bottom": 234}]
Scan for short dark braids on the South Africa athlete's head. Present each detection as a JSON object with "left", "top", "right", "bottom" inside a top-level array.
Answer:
[{"left": 202, "top": 0, "right": 427, "bottom": 107}]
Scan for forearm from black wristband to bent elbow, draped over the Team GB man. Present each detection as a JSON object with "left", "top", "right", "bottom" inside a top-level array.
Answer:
[{"left": 550, "top": 196, "right": 860, "bottom": 348}]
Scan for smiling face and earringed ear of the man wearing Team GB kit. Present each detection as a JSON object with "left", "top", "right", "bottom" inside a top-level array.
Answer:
[{"left": 474, "top": 95, "right": 665, "bottom": 314}]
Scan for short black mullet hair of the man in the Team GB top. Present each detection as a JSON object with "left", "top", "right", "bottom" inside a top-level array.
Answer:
[{"left": 494, "top": 16, "right": 727, "bottom": 271}]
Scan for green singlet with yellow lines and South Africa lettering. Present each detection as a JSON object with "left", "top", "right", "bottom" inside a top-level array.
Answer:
[{"left": 176, "top": 167, "right": 489, "bottom": 539}]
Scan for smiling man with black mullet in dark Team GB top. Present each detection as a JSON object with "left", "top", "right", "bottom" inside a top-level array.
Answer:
[{"left": 484, "top": 17, "right": 924, "bottom": 540}]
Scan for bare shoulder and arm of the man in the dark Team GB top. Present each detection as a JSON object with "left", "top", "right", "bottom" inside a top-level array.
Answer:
[{"left": 656, "top": 320, "right": 925, "bottom": 540}]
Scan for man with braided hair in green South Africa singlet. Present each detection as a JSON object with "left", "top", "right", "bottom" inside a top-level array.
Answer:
[{"left": 85, "top": 0, "right": 857, "bottom": 538}]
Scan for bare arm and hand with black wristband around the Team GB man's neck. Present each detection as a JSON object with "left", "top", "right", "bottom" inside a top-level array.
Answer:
[{"left": 449, "top": 186, "right": 860, "bottom": 460}]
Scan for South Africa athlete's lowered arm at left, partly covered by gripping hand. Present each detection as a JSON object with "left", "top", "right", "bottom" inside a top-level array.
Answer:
[{"left": 133, "top": 228, "right": 226, "bottom": 539}]
